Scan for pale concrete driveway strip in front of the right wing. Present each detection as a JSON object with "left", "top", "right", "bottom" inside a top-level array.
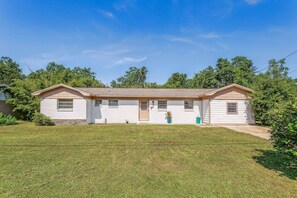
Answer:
[{"left": 218, "top": 125, "right": 270, "bottom": 140}]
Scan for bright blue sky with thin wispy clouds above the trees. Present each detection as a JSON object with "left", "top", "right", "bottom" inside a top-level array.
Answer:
[{"left": 0, "top": 0, "right": 297, "bottom": 83}]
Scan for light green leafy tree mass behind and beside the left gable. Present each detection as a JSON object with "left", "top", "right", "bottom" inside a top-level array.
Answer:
[{"left": 7, "top": 62, "right": 104, "bottom": 120}]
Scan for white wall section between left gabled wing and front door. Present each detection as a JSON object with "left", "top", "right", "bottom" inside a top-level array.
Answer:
[{"left": 89, "top": 100, "right": 139, "bottom": 123}]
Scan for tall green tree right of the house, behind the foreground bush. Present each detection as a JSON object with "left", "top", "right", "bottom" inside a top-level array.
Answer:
[{"left": 252, "top": 59, "right": 297, "bottom": 125}]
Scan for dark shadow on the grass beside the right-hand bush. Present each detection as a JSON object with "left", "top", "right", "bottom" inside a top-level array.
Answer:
[{"left": 253, "top": 149, "right": 297, "bottom": 180}]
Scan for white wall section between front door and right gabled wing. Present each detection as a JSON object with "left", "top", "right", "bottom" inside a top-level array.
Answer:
[{"left": 149, "top": 100, "right": 201, "bottom": 124}]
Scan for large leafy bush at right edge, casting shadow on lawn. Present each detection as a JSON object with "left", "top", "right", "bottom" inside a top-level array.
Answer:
[{"left": 270, "top": 101, "right": 297, "bottom": 168}]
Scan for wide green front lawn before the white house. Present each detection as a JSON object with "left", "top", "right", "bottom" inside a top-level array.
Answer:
[{"left": 0, "top": 123, "right": 297, "bottom": 197}]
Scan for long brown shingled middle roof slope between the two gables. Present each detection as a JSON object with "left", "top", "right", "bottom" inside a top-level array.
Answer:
[{"left": 76, "top": 88, "right": 212, "bottom": 98}]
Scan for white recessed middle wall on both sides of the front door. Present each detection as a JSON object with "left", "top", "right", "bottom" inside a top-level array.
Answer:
[{"left": 87, "top": 100, "right": 201, "bottom": 124}]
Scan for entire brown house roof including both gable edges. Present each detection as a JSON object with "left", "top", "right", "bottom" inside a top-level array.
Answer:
[{"left": 32, "top": 84, "right": 253, "bottom": 98}]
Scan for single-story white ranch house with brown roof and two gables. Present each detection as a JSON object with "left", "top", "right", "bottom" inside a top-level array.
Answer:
[{"left": 33, "top": 84, "right": 254, "bottom": 124}]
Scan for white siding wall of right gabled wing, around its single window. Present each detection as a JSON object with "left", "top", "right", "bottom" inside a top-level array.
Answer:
[{"left": 210, "top": 100, "right": 254, "bottom": 124}]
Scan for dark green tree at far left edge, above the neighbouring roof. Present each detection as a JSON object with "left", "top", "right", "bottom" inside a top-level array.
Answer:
[{"left": 0, "top": 57, "right": 24, "bottom": 85}]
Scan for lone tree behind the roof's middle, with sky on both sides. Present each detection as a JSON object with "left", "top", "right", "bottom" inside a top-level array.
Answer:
[{"left": 110, "top": 66, "right": 148, "bottom": 88}]
